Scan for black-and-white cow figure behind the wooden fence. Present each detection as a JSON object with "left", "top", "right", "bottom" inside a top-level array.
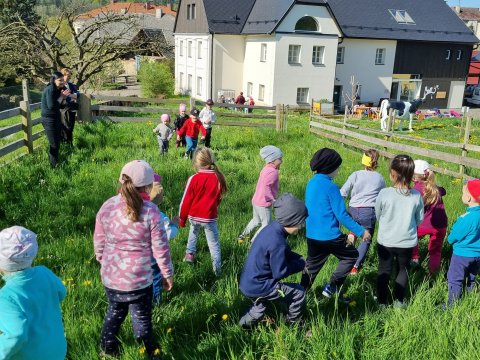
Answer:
[{"left": 380, "top": 85, "right": 438, "bottom": 131}]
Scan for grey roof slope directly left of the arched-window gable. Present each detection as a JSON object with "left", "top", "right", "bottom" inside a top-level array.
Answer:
[{"left": 242, "top": 0, "right": 295, "bottom": 34}]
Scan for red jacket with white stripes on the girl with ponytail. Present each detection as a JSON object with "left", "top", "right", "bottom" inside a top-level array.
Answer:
[{"left": 180, "top": 170, "right": 222, "bottom": 227}]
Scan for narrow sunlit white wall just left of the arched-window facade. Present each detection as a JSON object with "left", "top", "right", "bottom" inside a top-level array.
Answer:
[{"left": 246, "top": 35, "right": 276, "bottom": 105}]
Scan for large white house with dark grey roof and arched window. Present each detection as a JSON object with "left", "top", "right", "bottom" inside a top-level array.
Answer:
[{"left": 174, "top": 0, "right": 478, "bottom": 108}]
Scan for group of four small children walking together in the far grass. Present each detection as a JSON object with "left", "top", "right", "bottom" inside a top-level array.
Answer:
[{"left": 153, "top": 99, "right": 217, "bottom": 159}]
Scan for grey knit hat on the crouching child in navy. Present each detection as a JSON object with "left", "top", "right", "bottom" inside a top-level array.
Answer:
[{"left": 273, "top": 193, "right": 308, "bottom": 227}]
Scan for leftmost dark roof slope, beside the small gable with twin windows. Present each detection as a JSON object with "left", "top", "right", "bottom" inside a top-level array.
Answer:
[{"left": 203, "top": 0, "right": 255, "bottom": 34}]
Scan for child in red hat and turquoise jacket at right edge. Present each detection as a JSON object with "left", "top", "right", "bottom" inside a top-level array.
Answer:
[{"left": 447, "top": 179, "right": 480, "bottom": 305}]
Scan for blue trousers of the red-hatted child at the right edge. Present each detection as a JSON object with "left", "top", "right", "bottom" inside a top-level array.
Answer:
[{"left": 447, "top": 254, "right": 480, "bottom": 305}]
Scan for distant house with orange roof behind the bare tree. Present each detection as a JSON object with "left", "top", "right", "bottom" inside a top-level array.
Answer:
[{"left": 74, "top": 2, "right": 176, "bottom": 74}]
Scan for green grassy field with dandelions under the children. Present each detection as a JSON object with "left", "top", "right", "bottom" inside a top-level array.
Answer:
[{"left": 0, "top": 116, "right": 480, "bottom": 360}]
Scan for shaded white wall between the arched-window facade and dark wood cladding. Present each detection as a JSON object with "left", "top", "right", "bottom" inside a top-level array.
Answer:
[{"left": 335, "top": 39, "right": 397, "bottom": 105}]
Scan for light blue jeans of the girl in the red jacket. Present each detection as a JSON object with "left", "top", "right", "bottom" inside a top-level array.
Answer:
[{"left": 187, "top": 218, "right": 222, "bottom": 275}]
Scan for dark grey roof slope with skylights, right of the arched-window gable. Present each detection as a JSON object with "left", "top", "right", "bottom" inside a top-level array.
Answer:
[{"left": 328, "top": 0, "right": 478, "bottom": 44}]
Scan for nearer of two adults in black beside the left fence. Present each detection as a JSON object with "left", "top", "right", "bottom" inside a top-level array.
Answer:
[{"left": 42, "top": 71, "right": 70, "bottom": 167}]
